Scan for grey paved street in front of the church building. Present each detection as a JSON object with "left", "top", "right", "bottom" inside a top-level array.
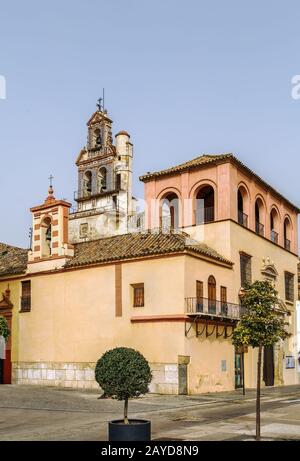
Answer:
[{"left": 0, "top": 385, "right": 300, "bottom": 441}]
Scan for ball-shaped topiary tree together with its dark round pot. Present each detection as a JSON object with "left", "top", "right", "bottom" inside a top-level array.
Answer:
[{"left": 95, "top": 347, "right": 152, "bottom": 441}]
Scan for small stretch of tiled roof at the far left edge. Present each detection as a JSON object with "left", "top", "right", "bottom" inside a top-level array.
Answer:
[{"left": 0, "top": 243, "right": 28, "bottom": 276}]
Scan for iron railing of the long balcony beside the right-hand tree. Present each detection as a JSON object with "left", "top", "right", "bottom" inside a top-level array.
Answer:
[{"left": 185, "top": 298, "right": 244, "bottom": 320}]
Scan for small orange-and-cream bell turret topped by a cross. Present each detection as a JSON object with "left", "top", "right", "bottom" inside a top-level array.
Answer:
[{"left": 28, "top": 181, "right": 74, "bottom": 272}]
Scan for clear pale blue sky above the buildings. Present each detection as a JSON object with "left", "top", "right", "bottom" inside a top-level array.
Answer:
[{"left": 0, "top": 0, "right": 300, "bottom": 246}]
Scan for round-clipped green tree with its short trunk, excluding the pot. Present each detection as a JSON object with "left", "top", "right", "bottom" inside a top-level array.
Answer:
[{"left": 95, "top": 347, "right": 152, "bottom": 424}]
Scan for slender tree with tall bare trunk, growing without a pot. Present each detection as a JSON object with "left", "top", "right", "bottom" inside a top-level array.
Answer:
[{"left": 232, "top": 280, "right": 290, "bottom": 440}]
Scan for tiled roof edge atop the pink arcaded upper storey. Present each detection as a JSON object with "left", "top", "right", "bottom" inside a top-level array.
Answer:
[{"left": 140, "top": 153, "right": 300, "bottom": 213}]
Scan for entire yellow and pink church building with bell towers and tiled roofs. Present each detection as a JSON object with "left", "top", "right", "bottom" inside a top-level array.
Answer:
[{"left": 0, "top": 105, "right": 299, "bottom": 394}]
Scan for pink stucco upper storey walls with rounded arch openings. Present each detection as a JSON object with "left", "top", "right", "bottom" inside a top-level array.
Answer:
[{"left": 145, "top": 156, "right": 298, "bottom": 254}]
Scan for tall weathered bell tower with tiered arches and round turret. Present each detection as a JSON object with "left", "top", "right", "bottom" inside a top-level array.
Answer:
[{"left": 69, "top": 100, "right": 135, "bottom": 243}]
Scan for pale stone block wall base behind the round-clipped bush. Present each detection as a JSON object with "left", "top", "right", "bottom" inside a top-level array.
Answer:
[{"left": 12, "top": 362, "right": 178, "bottom": 394}]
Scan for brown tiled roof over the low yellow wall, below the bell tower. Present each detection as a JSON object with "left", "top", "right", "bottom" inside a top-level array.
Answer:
[{"left": 65, "top": 231, "right": 233, "bottom": 267}]
